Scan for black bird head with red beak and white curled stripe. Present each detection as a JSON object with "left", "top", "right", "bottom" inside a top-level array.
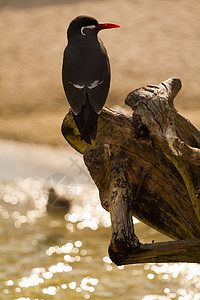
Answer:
[{"left": 67, "top": 16, "right": 120, "bottom": 38}]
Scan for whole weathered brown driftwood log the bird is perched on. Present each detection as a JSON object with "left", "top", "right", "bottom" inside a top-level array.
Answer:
[{"left": 62, "top": 78, "right": 200, "bottom": 265}]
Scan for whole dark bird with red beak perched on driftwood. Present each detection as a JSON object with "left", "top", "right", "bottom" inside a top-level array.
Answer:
[{"left": 62, "top": 16, "right": 120, "bottom": 145}]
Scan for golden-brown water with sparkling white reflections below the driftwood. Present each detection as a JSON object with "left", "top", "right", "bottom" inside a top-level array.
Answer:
[{"left": 0, "top": 145, "right": 200, "bottom": 300}]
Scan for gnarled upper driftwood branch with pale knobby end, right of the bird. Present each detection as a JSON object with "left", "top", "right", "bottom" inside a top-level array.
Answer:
[{"left": 125, "top": 78, "right": 200, "bottom": 220}]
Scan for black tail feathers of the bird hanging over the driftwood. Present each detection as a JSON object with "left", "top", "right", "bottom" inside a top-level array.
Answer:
[{"left": 73, "top": 95, "right": 99, "bottom": 145}]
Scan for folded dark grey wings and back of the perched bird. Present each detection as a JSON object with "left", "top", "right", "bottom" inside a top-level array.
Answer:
[{"left": 62, "top": 41, "right": 110, "bottom": 115}]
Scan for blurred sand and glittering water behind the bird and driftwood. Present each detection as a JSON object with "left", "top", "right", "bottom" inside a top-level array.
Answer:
[{"left": 0, "top": 0, "right": 200, "bottom": 300}]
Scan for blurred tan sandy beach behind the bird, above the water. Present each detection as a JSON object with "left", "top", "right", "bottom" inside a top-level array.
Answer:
[{"left": 0, "top": 0, "right": 200, "bottom": 145}]
